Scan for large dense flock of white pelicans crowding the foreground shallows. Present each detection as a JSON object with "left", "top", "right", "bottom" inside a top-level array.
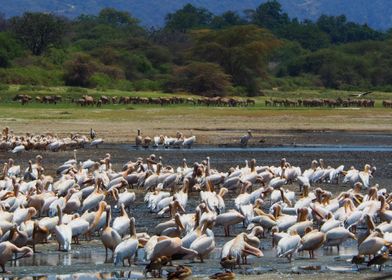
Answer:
[{"left": 0, "top": 148, "right": 392, "bottom": 279}]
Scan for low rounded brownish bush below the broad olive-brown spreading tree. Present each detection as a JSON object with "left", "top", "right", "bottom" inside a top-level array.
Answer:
[{"left": 166, "top": 62, "right": 231, "bottom": 96}]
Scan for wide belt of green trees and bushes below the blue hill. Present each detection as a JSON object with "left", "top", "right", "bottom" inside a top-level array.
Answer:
[{"left": 0, "top": 4, "right": 392, "bottom": 93}]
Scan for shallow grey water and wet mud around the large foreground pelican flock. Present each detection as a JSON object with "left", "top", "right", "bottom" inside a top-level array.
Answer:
[{"left": 0, "top": 144, "right": 392, "bottom": 279}]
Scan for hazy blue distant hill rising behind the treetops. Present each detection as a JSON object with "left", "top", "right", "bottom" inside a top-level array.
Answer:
[{"left": 0, "top": 0, "right": 392, "bottom": 30}]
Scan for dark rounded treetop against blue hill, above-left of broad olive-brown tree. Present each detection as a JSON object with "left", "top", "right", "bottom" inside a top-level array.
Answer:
[{"left": 165, "top": 4, "right": 212, "bottom": 32}]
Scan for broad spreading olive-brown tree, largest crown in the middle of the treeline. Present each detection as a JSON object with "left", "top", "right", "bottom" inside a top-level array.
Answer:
[{"left": 191, "top": 25, "right": 279, "bottom": 96}]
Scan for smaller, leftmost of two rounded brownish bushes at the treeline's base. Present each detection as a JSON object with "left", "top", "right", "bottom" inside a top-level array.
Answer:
[{"left": 64, "top": 53, "right": 96, "bottom": 87}]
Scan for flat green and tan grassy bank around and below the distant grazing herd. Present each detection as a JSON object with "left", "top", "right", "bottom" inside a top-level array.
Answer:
[{"left": 0, "top": 86, "right": 392, "bottom": 144}]
